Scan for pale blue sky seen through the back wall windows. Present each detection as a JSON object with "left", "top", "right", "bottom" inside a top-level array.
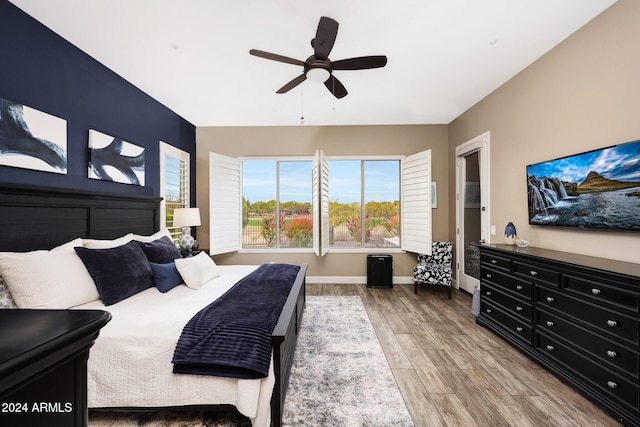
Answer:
[{"left": 242, "top": 160, "right": 400, "bottom": 203}]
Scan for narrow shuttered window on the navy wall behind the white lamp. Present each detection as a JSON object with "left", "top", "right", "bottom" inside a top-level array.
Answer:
[{"left": 160, "top": 141, "right": 190, "bottom": 242}]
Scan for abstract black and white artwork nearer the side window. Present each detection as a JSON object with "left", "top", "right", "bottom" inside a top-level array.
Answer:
[{"left": 89, "top": 129, "right": 145, "bottom": 185}]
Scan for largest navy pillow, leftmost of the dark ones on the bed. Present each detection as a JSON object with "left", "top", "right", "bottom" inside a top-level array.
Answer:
[{"left": 73, "top": 241, "right": 154, "bottom": 305}]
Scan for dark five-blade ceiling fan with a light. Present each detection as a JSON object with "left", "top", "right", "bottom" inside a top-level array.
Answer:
[{"left": 249, "top": 16, "right": 387, "bottom": 98}]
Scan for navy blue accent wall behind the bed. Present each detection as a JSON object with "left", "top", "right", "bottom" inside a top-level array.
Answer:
[{"left": 0, "top": 0, "right": 196, "bottom": 201}]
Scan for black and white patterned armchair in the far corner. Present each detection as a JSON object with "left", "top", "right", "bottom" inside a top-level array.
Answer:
[{"left": 413, "top": 242, "right": 453, "bottom": 298}]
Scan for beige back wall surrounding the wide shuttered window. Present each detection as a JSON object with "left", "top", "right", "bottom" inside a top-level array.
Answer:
[{"left": 196, "top": 125, "right": 450, "bottom": 277}]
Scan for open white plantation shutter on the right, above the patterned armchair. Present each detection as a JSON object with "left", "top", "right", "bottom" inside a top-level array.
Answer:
[{"left": 400, "top": 150, "right": 431, "bottom": 255}]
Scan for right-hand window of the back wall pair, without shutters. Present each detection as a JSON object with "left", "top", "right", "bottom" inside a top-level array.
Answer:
[{"left": 328, "top": 159, "right": 400, "bottom": 249}]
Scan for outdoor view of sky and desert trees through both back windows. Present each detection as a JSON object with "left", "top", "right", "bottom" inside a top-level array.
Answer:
[{"left": 242, "top": 160, "right": 400, "bottom": 249}]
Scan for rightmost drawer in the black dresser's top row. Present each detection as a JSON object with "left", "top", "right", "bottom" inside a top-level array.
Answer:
[{"left": 562, "top": 273, "right": 640, "bottom": 313}]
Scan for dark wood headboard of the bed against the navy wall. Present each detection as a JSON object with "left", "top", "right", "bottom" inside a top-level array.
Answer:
[{"left": 0, "top": 183, "right": 162, "bottom": 252}]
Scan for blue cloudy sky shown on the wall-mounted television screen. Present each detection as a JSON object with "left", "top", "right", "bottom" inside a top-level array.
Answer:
[{"left": 527, "top": 140, "right": 640, "bottom": 184}]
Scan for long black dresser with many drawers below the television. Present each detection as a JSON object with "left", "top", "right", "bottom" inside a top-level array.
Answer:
[{"left": 476, "top": 245, "right": 640, "bottom": 425}]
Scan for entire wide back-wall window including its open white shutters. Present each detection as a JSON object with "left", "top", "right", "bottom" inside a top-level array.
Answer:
[{"left": 209, "top": 150, "right": 431, "bottom": 256}]
